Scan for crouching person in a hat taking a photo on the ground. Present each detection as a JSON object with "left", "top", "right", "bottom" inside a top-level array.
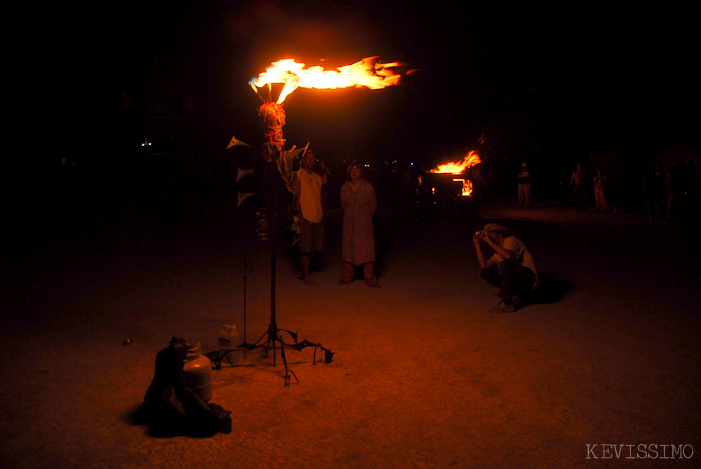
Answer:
[{"left": 473, "top": 223, "right": 539, "bottom": 313}]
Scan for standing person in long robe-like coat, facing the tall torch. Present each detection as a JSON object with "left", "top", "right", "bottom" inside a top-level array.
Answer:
[{"left": 338, "top": 161, "right": 380, "bottom": 288}]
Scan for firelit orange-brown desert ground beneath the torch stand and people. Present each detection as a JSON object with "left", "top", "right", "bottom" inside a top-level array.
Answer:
[{"left": 0, "top": 193, "right": 701, "bottom": 468}]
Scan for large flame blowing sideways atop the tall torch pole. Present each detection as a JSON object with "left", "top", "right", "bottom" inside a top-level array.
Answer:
[{"left": 249, "top": 57, "right": 402, "bottom": 104}]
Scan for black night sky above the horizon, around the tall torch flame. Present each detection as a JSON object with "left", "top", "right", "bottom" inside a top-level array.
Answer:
[{"left": 20, "top": 0, "right": 699, "bottom": 223}]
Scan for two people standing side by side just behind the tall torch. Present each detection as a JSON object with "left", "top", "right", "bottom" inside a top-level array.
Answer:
[{"left": 292, "top": 151, "right": 380, "bottom": 288}]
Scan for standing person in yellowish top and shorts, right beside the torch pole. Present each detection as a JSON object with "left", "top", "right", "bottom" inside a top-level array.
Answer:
[{"left": 292, "top": 151, "right": 328, "bottom": 286}]
